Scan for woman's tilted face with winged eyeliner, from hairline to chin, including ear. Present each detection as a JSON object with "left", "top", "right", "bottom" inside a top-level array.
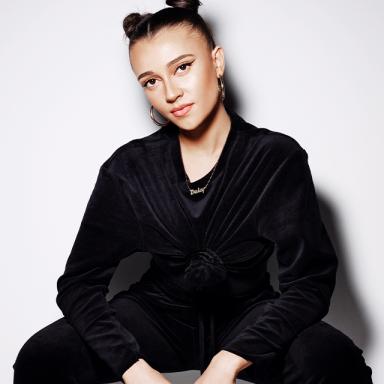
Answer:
[{"left": 129, "top": 26, "right": 224, "bottom": 130}]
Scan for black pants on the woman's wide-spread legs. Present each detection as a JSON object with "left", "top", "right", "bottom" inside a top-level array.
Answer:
[{"left": 13, "top": 283, "right": 372, "bottom": 384}]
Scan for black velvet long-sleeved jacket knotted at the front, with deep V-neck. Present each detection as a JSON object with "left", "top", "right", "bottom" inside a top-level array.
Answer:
[{"left": 57, "top": 110, "right": 337, "bottom": 377}]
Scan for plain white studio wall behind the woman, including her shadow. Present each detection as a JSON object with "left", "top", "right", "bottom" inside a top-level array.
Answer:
[{"left": 0, "top": 0, "right": 384, "bottom": 384}]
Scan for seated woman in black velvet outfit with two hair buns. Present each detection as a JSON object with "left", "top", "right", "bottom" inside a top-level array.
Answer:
[{"left": 14, "top": 0, "right": 372, "bottom": 384}]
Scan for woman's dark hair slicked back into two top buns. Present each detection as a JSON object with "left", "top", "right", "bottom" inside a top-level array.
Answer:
[{"left": 123, "top": 0, "right": 216, "bottom": 49}]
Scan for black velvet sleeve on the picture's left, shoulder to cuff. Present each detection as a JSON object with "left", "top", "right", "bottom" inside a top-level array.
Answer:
[{"left": 56, "top": 161, "right": 141, "bottom": 377}]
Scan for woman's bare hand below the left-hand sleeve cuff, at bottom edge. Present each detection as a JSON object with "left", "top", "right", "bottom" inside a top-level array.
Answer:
[{"left": 123, "top": 359, "right": 171, "bottom": 384}]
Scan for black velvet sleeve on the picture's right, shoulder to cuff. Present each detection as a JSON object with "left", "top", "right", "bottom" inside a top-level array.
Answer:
[{"left": 223, "top": 145, "right": 338, "bottom": 371}]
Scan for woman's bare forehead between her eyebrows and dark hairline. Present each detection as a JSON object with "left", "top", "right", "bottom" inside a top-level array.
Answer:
[{"left": 129, "top": 26, "right": 208, "bottom": 74}]
